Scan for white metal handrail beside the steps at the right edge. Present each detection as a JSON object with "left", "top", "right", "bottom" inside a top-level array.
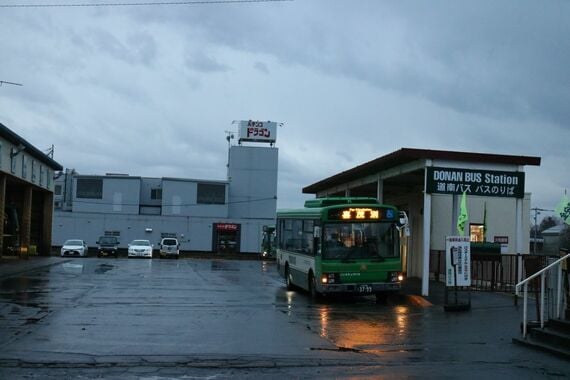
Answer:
[{"left": 515, "top": 250, "right": 570, "bottom": 338}]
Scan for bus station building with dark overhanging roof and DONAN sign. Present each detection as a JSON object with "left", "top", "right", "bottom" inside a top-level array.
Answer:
[{"left": 303, "top": 148, "right": 541, "bottom": 296}]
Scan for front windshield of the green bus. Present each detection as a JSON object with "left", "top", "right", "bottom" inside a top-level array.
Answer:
[{"left": 322, "top": 222, "right": 400, "bottom": 260}]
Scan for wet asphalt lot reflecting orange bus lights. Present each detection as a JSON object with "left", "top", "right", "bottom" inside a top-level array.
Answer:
[{"left": 0, "top": 258, "right": 570, "bottom": 379}]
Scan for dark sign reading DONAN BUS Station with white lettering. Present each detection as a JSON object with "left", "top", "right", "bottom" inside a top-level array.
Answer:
[{"left": 426, "top": 167, "right": 524, "bottom": 198}]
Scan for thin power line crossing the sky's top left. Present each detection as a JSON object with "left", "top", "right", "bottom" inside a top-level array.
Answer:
[{"left": 0, "top": 0, "right": 295, "bottom": 8}]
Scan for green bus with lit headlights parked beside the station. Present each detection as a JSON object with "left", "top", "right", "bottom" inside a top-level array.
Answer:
[{"left": 276, "top": 197, "right": 407, "bottom": 299}]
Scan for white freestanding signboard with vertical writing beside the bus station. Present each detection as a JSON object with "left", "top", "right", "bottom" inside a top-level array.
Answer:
[{"left": 445, "top": 236, "right": 471, "bottom": 286}]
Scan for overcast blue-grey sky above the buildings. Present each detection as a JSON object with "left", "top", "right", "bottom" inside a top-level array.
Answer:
[{"left": 0, "top": 0, "right": 570, "bottom": 220}]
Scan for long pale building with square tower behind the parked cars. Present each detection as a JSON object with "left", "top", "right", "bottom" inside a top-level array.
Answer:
[{"left": 53, "top": 138, "right": 278, "bottom": 253}]
